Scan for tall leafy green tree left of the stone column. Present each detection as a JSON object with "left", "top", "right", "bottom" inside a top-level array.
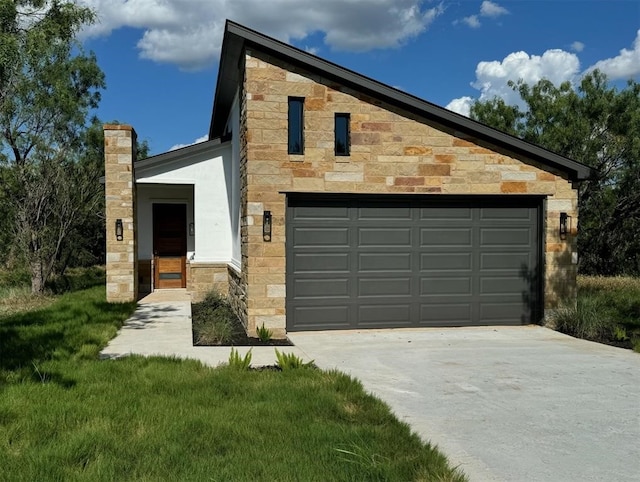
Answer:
[{"left": 0, "top": 0, "right": 104, "bottom": 293}]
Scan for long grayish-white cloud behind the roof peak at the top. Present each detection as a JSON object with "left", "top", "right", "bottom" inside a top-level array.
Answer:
[{"left": 76, "top": 0, "right": 444, "bottom": 70}]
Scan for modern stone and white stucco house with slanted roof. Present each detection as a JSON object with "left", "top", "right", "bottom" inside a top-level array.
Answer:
[{"left": 105, "top": 22, "right": 591, "bottom": 336}]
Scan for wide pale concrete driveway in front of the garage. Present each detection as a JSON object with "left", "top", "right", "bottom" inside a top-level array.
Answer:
[{"left": 290, "top": 326, "right": 640, "bottom": 482}]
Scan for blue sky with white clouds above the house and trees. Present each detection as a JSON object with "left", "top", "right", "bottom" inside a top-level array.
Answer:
[{"left": 76, "top": 0, "right": 640, "bottom": 154}]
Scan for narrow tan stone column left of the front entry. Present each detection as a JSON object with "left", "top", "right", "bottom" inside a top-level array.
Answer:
[{"left": 104, "top": 125, "right": 138, "bottom": 302}]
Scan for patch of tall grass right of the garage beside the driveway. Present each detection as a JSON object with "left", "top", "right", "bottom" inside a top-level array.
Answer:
[{"left": 551, "top": 276, "right": 640, "bottom": 352}]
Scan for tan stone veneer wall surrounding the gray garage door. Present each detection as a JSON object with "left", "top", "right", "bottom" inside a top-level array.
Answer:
[{"left": 241, "top": 51, "right": 577, "bottom": 333}]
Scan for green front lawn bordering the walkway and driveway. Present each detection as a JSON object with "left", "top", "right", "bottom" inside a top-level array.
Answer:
[{"left": 0, "top": 286, "right": 466, "bottom": 481}]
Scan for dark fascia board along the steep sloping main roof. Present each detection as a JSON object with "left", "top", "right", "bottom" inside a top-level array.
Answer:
[{"left": 209, "top": 20, "right": 594, "bottom": 181}]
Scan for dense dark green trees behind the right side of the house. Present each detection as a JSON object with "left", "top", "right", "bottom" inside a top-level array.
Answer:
[{"left": 471, "top": 71, "right": 640, "bottom": 275}]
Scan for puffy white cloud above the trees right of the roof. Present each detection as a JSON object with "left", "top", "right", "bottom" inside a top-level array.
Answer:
[{"left": 447, "top": 49, "right": 580, "bottom": 115}]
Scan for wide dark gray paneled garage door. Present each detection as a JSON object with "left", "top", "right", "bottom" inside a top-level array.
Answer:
[{"left": 287, "top": 195, "right": 542, "bottom": 331}]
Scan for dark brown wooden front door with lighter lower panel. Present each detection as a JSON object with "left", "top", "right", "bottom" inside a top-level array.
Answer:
[{"left": 153, "top": 204, "right": 187, "bottom": 289}]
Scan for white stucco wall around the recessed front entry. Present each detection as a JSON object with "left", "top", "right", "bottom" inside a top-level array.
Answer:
[{"left": 136, "top": 143, "right": 233, "bottom": 263}]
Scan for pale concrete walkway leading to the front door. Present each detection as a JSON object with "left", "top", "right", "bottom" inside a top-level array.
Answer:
[{"left": 100, "top": 290, "right": 310, "bottom": 367}]
